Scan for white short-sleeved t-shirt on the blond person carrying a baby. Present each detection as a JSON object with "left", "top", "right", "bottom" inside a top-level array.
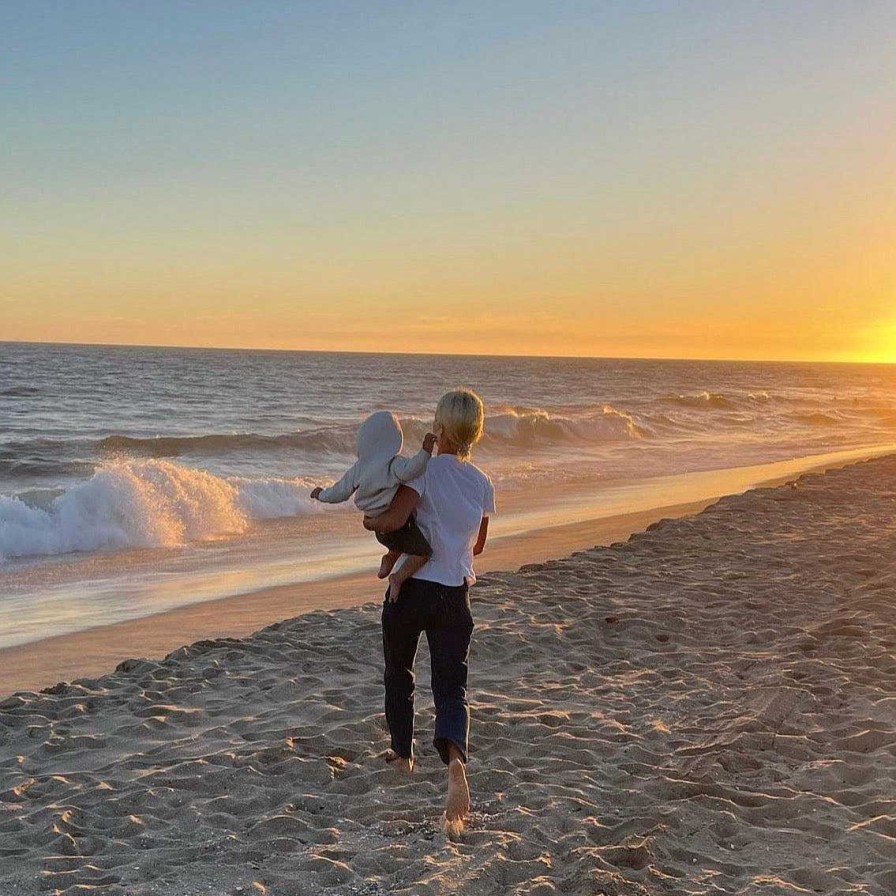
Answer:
[{"left": 407, "top": 454, "right": 495, "bottom": 586}]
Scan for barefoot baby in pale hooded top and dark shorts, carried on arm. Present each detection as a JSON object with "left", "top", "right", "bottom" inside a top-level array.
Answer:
[{"left": 311, "top": 411, "right": 436, "bottom": 600}]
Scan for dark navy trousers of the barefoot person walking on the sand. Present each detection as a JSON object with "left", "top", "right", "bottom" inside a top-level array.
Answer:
[{"left": 383, "top": 579, "right": 473, "bottom": 764}]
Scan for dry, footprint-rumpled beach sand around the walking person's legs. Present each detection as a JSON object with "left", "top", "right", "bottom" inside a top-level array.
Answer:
[{"left": 0, "top": 458, "right": 896, "bottom": 896}]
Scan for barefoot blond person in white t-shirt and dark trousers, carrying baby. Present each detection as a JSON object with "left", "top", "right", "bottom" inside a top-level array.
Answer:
[{"left": 364, "top": 389, "right": 495, "bottom": 835}]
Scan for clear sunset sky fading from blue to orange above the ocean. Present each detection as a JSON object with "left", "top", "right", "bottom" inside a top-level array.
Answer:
[{"left": 0, "top": 0, "right": 896, "bottom": 362}]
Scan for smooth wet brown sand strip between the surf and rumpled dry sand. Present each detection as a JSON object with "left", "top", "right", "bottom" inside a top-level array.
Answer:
[{"left": 0, "top": 446, "right": 893, "bottom": 699}]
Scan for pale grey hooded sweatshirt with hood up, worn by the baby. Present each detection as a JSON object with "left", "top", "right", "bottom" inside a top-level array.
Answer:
[{"left": 320, "top": 411, "right": 430, "bottom": 516}]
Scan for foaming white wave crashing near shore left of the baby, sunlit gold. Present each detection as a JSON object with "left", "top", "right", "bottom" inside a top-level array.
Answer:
[{"left": 0, "top": 460, "right": 315, "bottom": 561}]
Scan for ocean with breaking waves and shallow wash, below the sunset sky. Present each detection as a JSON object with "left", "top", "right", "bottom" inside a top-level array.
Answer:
[{"left": 0, "top": 343, "right": 896, "bottom": 646}]
